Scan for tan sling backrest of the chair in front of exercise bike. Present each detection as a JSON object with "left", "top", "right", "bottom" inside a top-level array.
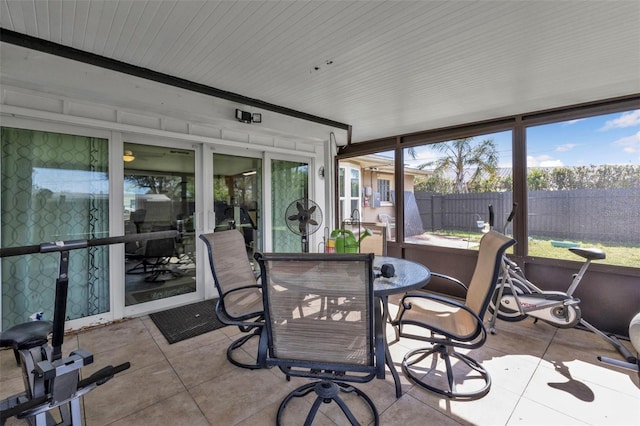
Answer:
[{"left": 465, "top": 231, "right": 516, "bottom": 318}]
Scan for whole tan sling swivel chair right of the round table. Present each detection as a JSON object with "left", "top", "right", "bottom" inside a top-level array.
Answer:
[{"left": 393, "top": 231, "right": 515, "bottom": 399}]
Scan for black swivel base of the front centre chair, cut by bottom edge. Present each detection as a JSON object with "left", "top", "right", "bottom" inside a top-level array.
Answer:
[{"left": 276, "top": 380, "right": 380, "bottom": 426}]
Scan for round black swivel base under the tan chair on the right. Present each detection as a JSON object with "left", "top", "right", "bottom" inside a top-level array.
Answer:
[{"left": 402, "top": 344, "right": 491, "bottom": 400}]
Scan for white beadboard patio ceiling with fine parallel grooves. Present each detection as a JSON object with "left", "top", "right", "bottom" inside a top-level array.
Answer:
[{"left": 0, "top": 0, "right": 640, "bottom": 142}]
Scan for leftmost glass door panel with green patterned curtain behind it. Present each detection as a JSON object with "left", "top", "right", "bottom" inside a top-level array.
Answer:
[{"left": 0, "top": 127, "right": 109, "bottom": 329}]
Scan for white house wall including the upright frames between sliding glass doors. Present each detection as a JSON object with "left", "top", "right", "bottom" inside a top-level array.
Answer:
[{"left": 0, "top": 43, "right": 347, "bottom": 328}]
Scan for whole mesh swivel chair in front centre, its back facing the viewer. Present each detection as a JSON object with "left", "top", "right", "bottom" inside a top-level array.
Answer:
[{"left": 255, "top": 253, "right": 384, "bottom": 425}]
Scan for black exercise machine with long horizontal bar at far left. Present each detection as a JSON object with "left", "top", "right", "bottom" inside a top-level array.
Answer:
[{"left": 0, "top": 231, "right": 177, "bottom": 426}]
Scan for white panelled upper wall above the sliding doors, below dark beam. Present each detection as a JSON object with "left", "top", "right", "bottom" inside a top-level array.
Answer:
[{"left": 0, "top": 43, "right": 347, "bottom": 236}]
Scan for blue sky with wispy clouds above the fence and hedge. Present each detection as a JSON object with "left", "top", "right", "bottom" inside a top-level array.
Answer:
[{"left": 405, "top": 109, "right": 640, "bottom": 167}]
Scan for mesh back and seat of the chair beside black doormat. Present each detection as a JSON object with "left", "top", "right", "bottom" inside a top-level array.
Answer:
[{"left": 200, "top": 229, "right": 257, "bottom": 317}]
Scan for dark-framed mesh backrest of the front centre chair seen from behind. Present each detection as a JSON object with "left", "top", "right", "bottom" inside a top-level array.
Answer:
[{"left": 255, "top": 253, "right": 384, "bottom": 380}]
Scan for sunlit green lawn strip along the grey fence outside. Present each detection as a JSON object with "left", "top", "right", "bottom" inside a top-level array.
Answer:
[{"left": 422, "top": 230, "right": 640, "bottom": 268}]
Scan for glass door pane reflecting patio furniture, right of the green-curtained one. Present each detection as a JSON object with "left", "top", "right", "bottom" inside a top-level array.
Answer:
[{"left": 123, "top": 142, "right": 197, "bottom": 306}]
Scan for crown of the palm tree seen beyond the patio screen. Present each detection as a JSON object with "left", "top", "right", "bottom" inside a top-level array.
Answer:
[{"left": 418, "top": 138, "right": 498, "bottom": 193}]
